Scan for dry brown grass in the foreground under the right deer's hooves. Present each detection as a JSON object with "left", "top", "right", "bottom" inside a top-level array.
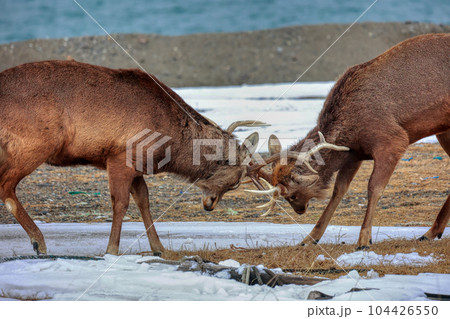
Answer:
[{"left": 163, "top": 238, "right": 450, "bottom": 278}]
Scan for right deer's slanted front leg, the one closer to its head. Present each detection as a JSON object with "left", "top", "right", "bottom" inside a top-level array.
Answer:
[{"left": 301, "top": 159, "right": 361, "bottom": 246}]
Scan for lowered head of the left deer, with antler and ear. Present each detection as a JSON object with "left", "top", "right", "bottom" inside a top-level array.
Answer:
[{"left": 196, "top": 120, "right": 268, "bottom": 211}]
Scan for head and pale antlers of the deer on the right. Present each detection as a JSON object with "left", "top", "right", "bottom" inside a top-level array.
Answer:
[{"left": 247, "top": 132, "right": 349, "bottom": 216}]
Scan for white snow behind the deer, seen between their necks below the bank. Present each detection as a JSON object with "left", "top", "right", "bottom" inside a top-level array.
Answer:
[{"left": 175, "top": 82, "right": 437, "bottom": 152}]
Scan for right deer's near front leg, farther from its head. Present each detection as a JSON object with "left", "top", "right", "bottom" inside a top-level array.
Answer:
[{"left": 357, "top": 138, "right": 408, "bottom": 250}]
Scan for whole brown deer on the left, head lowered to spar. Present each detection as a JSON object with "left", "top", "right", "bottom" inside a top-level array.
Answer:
[{"left": 0, "top": 61, "right": 263, "bottom": 254}]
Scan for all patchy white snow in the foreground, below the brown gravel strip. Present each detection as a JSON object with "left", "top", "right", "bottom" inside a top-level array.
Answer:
[{"left": 0, "top": 222, "right": 450, "bottom": 301}]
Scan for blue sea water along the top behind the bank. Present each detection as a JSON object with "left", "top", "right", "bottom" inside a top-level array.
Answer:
[{"left": 0, "top": 0, "right": 450, "bottom": 43}]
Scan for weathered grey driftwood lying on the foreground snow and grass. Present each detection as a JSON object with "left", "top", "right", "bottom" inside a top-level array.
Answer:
[{"left": 141, "top": 256, "right": 327, "bottom": 287}]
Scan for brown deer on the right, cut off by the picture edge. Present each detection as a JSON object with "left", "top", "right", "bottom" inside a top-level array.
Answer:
[{"left": 249, "top": 34, "right": 450, "bottom": 249}]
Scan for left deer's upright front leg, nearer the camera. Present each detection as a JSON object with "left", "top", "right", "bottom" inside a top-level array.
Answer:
[{"left": 106, "top": 158, "right": 136, "bottom": 255}]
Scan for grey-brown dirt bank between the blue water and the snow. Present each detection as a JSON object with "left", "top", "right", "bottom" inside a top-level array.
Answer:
[{"left": 0, "top": 23, "right": 450, "bottom": 87}]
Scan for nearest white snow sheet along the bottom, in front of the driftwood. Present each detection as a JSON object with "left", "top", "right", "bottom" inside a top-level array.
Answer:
[{"left": 0, "top": 255, "right": 450, "bottom": 300}]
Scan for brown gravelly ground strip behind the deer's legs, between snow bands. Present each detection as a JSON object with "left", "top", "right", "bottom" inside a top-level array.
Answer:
[{"left": 0, "top": 144, "right": 450, "bottom": 226}]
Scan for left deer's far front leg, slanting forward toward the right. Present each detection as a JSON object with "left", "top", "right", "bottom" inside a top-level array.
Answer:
[{"left": 131, "top": 176, "right": 164, "bottom": 256}]
